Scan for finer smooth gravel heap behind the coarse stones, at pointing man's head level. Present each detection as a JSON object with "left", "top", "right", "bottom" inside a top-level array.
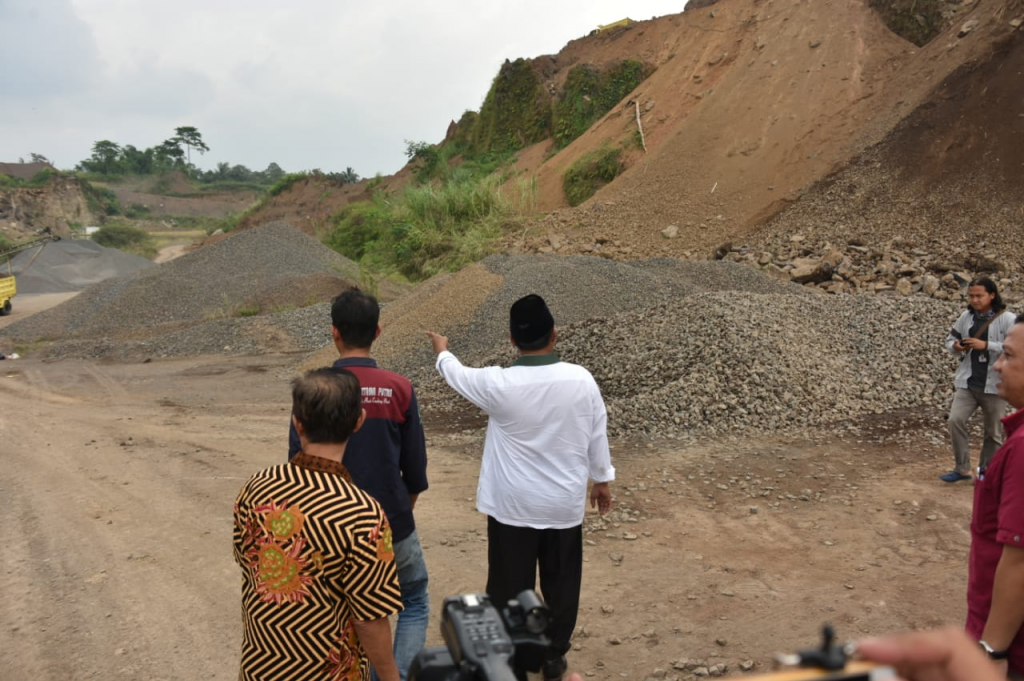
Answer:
[{"left": 303, "top": 255, "right": 809, "bottom": 379}]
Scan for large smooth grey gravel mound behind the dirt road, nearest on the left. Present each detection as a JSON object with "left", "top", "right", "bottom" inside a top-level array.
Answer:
[{"left": 2, "top": 222, "right": 358, "bottom": 346}]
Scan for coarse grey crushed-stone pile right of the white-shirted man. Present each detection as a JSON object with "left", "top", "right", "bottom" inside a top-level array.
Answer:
[{"left": 413, "top": 293, "right": 959, "bottom": 438}]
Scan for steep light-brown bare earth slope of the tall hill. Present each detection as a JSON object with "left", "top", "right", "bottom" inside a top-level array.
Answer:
[{"left": 524, "top": 0, "right": 1020, "bottom": 257}]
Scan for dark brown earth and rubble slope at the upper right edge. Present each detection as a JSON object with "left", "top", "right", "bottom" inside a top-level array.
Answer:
[{"left": 750, "top": 26, "right": 1024, "bottom": 287}]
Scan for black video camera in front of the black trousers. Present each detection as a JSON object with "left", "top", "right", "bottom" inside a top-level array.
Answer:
[{"left": 409, "top": 590, "right": 551, "bottom": 681}]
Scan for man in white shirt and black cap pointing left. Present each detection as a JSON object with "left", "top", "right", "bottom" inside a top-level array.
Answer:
[{"left": 427, "top": 295, "right": 615, "bottom": 681}]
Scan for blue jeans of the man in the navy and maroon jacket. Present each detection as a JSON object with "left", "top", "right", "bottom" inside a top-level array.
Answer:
[{"left": 373, "top": 530, "right": 430, "bottom": 681}]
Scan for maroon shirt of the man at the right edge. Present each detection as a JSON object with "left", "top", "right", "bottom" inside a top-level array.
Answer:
[{"left": 967, "top": 401, "right": 1024, "bottom": 674}]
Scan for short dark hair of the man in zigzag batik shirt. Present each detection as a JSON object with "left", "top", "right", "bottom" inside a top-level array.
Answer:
[{"left": 292, "top": 369, "right": 362, "bottom": 444}]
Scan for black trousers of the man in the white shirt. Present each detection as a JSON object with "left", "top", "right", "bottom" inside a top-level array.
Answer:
[{"left": 487, "top": 516, "right": 583, "bottom": 672}]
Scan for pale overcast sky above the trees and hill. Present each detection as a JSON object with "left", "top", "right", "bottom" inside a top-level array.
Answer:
[{"left": 0, "top": 0, "right": 686, "bottom": 176}]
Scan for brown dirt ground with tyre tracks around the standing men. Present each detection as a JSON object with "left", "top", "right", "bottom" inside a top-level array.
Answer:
[{"left": 0, "top": 355, "right": 971, "bottom": 680}]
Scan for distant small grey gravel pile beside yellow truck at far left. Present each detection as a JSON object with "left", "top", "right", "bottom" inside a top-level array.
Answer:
[{"left": 10, "top": 239, "right": 156, "bottom": 294}]
